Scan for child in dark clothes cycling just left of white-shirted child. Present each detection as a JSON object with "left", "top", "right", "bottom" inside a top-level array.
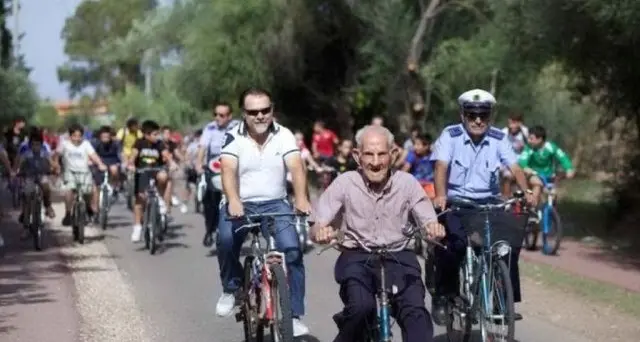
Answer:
[{"left": 16, "top": 129, "right": 55, "bottom": 238}]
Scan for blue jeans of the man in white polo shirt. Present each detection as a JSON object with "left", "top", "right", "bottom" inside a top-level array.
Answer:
[{"left": 216, "top": 199, "right": 305, "bottom": 317}]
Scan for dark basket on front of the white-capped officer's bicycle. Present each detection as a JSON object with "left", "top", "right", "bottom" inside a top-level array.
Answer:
[{"left": 461, "top": 211, "right": 527, "bottom": 248}]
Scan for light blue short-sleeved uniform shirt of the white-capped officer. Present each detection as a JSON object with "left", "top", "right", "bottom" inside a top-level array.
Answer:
[{"left": 431, "top": 124, "right": 517, "bottom": 199}]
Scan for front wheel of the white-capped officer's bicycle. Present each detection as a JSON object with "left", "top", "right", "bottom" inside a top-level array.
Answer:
[{"left": 480, "top": 259, "right": 515, "bottom": 342}]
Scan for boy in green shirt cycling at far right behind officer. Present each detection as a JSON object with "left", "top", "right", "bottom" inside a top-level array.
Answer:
[{"left": 518, "top": 126, "right": 576, "bottom": 203}]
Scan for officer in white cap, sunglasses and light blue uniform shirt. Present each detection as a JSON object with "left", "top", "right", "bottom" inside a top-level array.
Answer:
[{"left": 431, "top": 89, "right": 535, "bottom": 325}]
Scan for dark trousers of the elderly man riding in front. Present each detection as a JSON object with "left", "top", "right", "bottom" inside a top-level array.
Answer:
[{"left": 333, "top": 250, "right": 433, "bottom": 342}]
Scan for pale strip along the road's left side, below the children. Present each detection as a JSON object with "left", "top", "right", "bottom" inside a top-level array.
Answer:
[{"left": 50, "top": 204, "right": 151, "bottom": 342}]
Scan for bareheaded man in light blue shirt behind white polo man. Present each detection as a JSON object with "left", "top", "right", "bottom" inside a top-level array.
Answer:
[{"left": 195, "top": 102, "right": 239, "bottom": 247}]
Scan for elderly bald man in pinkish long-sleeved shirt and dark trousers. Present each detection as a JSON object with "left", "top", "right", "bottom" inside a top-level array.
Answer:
[{"left": 311, "top": 126, "right": 444, "bottom": 342}]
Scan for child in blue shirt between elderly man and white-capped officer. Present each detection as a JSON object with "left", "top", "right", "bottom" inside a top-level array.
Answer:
[{"left": 402, "top": 134, "right": 435, "bottom": 199}]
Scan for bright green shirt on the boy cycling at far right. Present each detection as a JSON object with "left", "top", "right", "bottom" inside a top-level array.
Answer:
[{"left": 518, "top": 141, "right": 573, "bottom": 177}]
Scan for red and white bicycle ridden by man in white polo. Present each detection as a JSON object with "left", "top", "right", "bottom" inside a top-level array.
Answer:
[{"left": 227, "top": 213, "right": 297, "bottom": 342}]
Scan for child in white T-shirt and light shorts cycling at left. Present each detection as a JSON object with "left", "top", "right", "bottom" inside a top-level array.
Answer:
[{"left": 57, "top": 124, "right": 107, "bottom": 226}]
